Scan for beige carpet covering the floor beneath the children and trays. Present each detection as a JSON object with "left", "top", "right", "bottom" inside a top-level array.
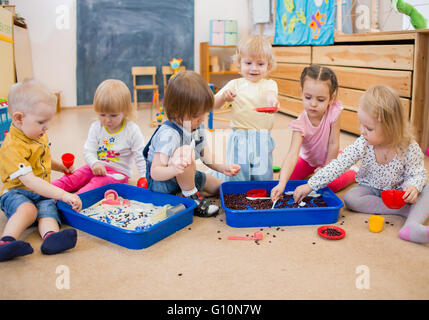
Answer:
[{"left": 0, "top": 107, "right": 429, "bottom": 300}]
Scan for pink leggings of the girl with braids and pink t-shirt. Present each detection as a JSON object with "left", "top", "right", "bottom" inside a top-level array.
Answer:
[{"left": 289, "top": 157, "right": 356, "bottom": 192}]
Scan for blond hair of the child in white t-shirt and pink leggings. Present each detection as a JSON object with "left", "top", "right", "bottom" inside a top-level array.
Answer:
[{"left": 93, "top": 79, "right": 135, "bottom": 119}]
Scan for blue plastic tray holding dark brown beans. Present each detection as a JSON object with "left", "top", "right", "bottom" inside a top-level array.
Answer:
[{"left": 220, "top": 180, "right": 344, "bottom": 228}]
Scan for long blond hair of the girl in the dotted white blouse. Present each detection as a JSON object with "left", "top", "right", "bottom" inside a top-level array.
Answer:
[{"left": 359, "top": 85, "right": 414, "bottom": 152}]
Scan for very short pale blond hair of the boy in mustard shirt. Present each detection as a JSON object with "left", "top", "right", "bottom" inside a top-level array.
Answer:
[{"left": 8, "top": 78, "right": 57, "bottom": 115}]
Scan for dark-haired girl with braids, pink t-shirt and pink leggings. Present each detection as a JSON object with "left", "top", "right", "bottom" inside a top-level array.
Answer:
[{"left": 271, "top": 65, "right": 357, "bottom": 201}]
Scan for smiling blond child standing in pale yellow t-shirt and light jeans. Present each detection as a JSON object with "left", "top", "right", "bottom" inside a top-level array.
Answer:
[{"left": 209, "top": 35, "right": 280, "bottom": 181}]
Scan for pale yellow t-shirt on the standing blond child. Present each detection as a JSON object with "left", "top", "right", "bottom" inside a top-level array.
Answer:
[{"left": 218, "top": 78, "right": 278, "bottom": 130}]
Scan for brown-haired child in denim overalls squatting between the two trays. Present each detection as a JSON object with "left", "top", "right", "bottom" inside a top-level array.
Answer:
[{"left": 144, "top": 71, "right": 240, "bottom": 217}]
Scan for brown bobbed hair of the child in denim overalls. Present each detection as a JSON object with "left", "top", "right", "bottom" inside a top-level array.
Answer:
[{"left": 164, "top": 70, "right": 214, "bottom": 125}]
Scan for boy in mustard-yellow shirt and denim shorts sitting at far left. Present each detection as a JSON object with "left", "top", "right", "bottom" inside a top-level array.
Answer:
[{"left": 0, "top": 79, "right": 82, "bottom": 261}]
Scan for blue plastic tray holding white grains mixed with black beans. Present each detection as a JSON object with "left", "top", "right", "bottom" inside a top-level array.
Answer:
[{"left": 57, "top": 183, "right": 197, "bottom": 249}]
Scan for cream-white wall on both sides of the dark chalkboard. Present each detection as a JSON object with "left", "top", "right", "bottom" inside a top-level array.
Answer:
[{"left": 10, "top": 0, "right": 249, "bottom": 107}]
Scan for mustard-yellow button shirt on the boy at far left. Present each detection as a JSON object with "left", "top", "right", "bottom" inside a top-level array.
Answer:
[{"left": 0, "top": 124, "right": 51, "bottom": 194}]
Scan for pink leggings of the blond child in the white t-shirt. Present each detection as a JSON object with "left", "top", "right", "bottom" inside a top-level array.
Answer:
[{"left": 52, "top": 165, "right": 128, "bottom": 193}]
